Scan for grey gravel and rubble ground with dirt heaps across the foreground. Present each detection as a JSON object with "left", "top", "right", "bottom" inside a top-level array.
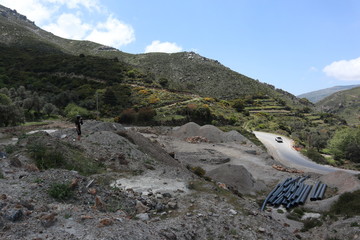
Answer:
[{"left": 0, "top": 121, "right": 359, "bottom": 240}]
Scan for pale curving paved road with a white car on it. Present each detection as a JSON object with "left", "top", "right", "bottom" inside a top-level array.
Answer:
[{"left": 254, "top": 132, "right": 360, "bottom": 174}]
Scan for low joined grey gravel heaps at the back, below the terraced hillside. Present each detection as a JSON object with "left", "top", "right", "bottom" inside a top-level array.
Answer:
[{"left": 172, "top": 122, "right": 247, "bottom": 143}]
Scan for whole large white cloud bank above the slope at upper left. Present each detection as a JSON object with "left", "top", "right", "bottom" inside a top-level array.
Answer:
[{"left": 0, "top": 0, "right": 135, "bottom": 48}]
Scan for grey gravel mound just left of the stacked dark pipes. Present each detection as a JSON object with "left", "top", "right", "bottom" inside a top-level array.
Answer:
[{"left": 206, "top": 164, "right": 266, "bottom": 195}]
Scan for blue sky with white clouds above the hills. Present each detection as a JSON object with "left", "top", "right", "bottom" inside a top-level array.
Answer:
[{"left": 0, "top": 0, "right": 360, "bottom": 95}]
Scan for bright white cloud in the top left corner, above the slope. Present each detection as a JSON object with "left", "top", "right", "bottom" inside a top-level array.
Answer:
[{"left": 0, "top": 0, "right": 56, "bottom": 25}]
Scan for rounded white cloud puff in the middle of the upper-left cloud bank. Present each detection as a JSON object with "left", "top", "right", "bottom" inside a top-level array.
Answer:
[{"left": 43, "top": 13, "right": 91, "bottom": 40}]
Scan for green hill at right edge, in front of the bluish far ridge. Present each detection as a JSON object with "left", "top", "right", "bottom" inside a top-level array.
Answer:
[{"left": 316, "top": 87, "right": 360, "bottom": 125}]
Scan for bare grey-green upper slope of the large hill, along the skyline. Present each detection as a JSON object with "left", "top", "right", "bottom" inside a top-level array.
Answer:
[{"left": 0, "top": 5, "right": 304, "bottom": 108}]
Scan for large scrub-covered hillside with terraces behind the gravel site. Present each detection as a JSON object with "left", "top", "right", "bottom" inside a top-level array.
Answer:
[{"left": 0, "top": 2, "right": 356, "bottom": 170}]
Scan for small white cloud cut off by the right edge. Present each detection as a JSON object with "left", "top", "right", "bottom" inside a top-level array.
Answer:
[{"left": 323, "top": 57, "right": 360, "bottom": 81}]
